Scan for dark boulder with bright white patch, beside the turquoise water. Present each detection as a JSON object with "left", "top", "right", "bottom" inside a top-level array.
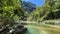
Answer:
[{"left": 9, "top": 25, "right": 27, "bottom": 34}]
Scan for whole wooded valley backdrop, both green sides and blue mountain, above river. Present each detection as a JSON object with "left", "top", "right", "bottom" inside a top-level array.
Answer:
[{"left": 0, "top": 0, "right": 60, "bottom": 33}]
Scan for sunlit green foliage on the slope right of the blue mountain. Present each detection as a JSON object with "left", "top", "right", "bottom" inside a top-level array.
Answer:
[{"left": 28, "top": 0, "right": 60, "bottom": 21}]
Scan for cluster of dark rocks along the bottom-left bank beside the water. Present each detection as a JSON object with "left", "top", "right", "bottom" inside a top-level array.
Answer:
[{"left": 0, "top": 24, "right": 27, "bottom": 34}]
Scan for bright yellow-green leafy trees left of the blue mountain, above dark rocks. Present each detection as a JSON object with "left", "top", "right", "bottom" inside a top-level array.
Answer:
[{"left": 0, "top": 0, "right": 22, "bottom": 24}]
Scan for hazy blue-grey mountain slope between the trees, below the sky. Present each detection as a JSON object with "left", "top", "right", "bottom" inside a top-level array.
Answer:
[{"left": 21, "top": 1, "right": 36, "bottom": 14}]
